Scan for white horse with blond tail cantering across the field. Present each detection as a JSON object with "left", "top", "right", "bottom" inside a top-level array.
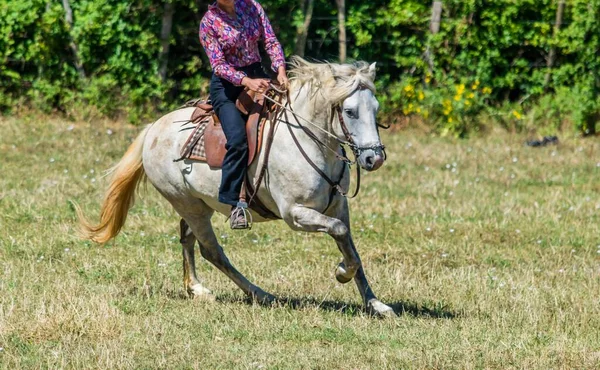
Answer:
[{"left": 80, "top": 58, "right": 394, "bottom": 316}]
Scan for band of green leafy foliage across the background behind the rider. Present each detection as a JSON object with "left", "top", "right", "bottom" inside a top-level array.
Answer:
[{"left": 0, "top": 0, "right": 600, "bottom": 136}]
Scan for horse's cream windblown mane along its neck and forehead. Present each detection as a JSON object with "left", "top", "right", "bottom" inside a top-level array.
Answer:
[{"left": 290, "top": 56, "right": 375, "bottom": 105}]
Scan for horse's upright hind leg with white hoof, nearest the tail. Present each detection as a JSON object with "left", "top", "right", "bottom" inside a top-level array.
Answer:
[{"left": 179, "top": 219, "right": 214, "bottom": 299}]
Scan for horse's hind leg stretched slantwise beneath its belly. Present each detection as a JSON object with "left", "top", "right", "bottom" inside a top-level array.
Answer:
[{"left": 184, "top": 214, "right": 275, "bottom": 303}]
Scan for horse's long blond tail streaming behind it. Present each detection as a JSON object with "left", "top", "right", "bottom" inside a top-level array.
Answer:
[{"left": 75, "top": 125, "right": 150, "bottom": 243}]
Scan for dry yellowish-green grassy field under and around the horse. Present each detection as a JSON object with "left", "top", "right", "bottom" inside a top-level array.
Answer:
[{"left": 0, "top": 117, "right": 600, "bottom": 369}]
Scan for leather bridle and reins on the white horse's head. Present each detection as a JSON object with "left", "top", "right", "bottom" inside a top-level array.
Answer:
[{"left": 264, "top": 84, "right": 389, "bottom": 199}]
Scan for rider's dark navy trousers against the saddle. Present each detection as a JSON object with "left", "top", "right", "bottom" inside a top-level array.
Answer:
[{"left": 210, "top": 63, "right": 268, "bottom": 206}]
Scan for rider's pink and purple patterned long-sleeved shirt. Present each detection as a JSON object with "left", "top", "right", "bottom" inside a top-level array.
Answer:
[{"left": 200, "top": 0, "right": 285, "bottom": 86}]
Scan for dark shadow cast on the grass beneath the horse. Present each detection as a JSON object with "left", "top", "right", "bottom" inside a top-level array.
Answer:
[{"left": 217, "top": 295, "right": 461, "bottom": 319}]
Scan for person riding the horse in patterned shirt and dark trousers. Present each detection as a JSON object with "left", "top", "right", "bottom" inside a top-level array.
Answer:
[{"left": 200, "top": 0, "right": 288, "bottom": 229}]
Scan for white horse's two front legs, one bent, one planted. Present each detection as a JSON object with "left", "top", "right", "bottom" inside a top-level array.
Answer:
[{"left": 290, "top": 201, "right": 395, "bottom": 316}]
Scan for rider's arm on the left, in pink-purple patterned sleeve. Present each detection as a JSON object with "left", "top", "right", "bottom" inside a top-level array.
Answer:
[{"left": 200, "top": 17, "right": 246, "bottom": 86}]
